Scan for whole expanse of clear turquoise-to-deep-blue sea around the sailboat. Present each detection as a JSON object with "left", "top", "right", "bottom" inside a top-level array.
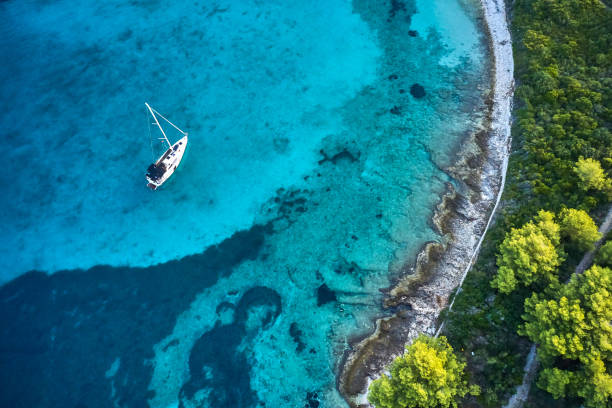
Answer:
[{"left": 0, "top": 0, "right": 489, "bottom": 408}]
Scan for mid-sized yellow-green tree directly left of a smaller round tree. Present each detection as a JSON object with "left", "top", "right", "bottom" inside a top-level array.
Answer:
[{"left": 491, "top": 211, "right": 563, "bottom": 293}]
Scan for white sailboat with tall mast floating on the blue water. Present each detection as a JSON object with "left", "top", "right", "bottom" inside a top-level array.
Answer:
[{"left": 145, "top": 102, "right": 187, "bottom": 191}]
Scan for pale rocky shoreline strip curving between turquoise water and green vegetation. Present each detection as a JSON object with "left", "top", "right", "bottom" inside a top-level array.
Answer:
[{"left": 337, "top": 0, "right": 514, "bottom": 407}]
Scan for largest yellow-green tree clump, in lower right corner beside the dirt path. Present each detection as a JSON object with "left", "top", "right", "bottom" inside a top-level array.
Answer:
[{"left": 519, "top": 266, "right": 612, "bottom": 408}]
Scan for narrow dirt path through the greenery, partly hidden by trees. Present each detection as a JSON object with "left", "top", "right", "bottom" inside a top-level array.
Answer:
[{"left": 504, "top": 206, "right": 612, "bottom": 408}]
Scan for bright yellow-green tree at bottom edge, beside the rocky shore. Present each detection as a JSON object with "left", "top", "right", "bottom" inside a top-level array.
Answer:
[{"left": 368, "top": 335, "right": 480, "bottom": 408}]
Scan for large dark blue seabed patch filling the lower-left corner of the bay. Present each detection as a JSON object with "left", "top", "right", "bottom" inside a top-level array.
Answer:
[{"left": 0, "top": 225, "right": 270, "bottom": 408}]
